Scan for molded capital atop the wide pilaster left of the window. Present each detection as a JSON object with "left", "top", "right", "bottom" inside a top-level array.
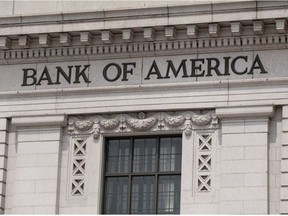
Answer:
[{"left": 11, "top": 114, "right": 67, "bottom": 127}]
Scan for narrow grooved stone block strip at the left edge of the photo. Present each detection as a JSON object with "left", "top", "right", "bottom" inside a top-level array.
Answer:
[{"left": 0, "top": 118, "right": 8, "bottom": 214}]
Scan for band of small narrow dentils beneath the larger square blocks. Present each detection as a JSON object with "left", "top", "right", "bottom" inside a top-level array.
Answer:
[{"left": 0, "top": 34, "right": 288, "bottom": 64}]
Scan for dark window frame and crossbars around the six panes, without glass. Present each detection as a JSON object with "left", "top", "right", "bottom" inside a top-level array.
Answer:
[{"left": 101, "top": 134, "right": 183, "bottom": 214}]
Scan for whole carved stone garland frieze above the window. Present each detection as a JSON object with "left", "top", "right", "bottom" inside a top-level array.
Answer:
[{"left": 68, "top": 111, "right": 219, "bottom": 139}]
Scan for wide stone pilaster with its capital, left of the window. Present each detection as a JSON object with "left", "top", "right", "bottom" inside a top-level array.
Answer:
[{"left": 12, "top": 115, "right": 66, "bottom": 214}]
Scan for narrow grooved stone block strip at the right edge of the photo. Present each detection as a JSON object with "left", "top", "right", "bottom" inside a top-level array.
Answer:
[{"left": 280, "top": 106, "right": 288, "bottom": 214}]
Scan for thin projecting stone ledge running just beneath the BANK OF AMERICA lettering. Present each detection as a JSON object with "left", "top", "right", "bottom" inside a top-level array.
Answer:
[{"left": 0, "top": 77, "right": 288, "bottom": 98}]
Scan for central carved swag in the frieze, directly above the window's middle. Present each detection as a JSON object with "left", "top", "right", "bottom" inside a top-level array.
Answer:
[{"left": 126, "top": 112, "right": 157, "bottom": 131}]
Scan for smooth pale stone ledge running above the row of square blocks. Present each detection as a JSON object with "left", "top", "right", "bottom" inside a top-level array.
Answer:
[{"left": 0, "top": 1, "right": 288, "bottom": 26}]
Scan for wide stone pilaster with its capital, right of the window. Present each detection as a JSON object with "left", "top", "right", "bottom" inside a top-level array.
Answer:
[{"left": 216, "top": 106, "right": 274, "bottom": 214}]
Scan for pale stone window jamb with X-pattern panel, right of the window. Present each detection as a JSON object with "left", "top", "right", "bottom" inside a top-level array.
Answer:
[{"left": 180, "top": 127, "right": 219, "bottom": 214}]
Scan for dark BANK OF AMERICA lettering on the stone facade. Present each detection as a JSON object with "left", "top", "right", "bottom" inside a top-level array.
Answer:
[{"left": 21, "top": 54, "right": 268, "bottom": 87}]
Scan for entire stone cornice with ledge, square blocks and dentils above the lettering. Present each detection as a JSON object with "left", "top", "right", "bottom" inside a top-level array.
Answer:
[{"left": 0, "top": 1, "right": 288, "bottom": 64}]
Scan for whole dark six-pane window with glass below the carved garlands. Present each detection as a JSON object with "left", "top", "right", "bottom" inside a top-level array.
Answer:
[{"left": 103, "top": 137, "right": 182, "bottom": 214}]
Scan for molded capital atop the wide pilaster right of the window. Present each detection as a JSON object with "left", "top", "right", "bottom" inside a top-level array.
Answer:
[{"left": 215, "top": 105, "right": 274, "bottom": 119}]
